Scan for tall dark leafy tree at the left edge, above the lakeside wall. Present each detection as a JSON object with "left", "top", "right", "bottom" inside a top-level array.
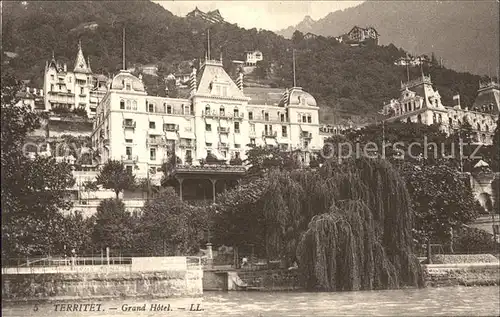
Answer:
[{"left": 1, "top": 73, "right": 75, "bottom": 258}]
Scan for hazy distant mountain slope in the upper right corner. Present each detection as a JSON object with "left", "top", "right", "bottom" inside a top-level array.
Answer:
[{"left": 277, "top": 0, "right": 500, "bottom": 75}]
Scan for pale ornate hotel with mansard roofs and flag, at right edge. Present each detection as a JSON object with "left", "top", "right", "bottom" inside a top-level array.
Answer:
[{"left": 383, "top": 74, "right": 500, "bottom": 144}]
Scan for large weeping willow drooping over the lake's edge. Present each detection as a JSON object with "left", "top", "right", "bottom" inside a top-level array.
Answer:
[{"left": 213, "top": 158, "right": 423, "bottom": 291}]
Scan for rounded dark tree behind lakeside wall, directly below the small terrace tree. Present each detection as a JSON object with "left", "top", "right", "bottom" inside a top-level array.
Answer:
[{"left": 92, "top": 199, "right": 134, "bottom": 252}]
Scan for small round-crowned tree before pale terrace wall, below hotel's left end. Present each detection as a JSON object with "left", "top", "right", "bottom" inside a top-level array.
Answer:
[{"left": 96, "top": 160, "right": 135, "bottom": 199}]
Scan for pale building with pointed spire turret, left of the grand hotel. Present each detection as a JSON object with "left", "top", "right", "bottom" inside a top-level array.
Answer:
[{"left": 43, "top": 43, "right": 108, "bottom": 117}]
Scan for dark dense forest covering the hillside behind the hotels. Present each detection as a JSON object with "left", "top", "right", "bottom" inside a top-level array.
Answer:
[{"left": 2, "top": 1, "right": 492, "bottom": 121}]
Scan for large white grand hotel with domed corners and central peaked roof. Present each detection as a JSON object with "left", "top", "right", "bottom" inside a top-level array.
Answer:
[{"left": 92, "top": 59, "right": 322, "bottom": 193}]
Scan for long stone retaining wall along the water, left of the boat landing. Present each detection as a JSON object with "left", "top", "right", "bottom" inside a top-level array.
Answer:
[{"left": 2, "top": 270, "right": 203, "bottom": 300}]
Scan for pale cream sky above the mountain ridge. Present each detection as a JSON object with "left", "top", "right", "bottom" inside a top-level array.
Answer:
[{"left": 153, "top": 0, "right": 363, "bottom": 31}]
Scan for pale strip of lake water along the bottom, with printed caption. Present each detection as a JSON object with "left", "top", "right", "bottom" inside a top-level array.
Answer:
[{"left": 2, "top": 286, "right": 500, "bottom": 317}]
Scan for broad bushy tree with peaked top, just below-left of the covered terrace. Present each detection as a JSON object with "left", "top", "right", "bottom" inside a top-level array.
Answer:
[{"left": 138, "top": 188, "right": 208, "bottom": 255}]
